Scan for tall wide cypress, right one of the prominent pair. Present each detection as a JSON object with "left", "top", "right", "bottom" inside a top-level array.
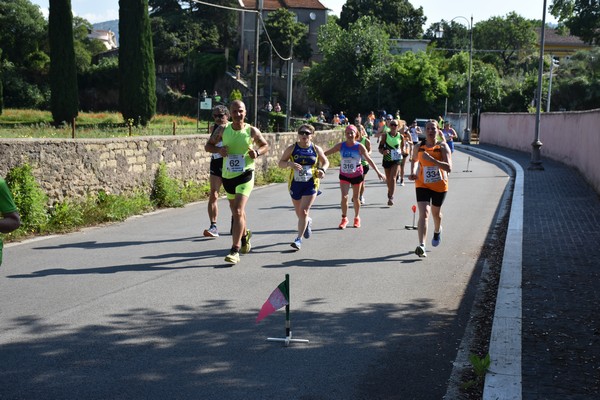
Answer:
[{"left": 119, "top": 0, "right": 156, "bottom": 126}]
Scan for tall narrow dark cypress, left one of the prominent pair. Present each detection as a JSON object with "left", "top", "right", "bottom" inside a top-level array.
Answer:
[{"left": 48, "top": 0, "right": 79, "bottom": 124}]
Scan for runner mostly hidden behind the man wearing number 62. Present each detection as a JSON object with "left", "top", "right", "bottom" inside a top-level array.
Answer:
[{"left": 204, "top": 105, "right": 229, "bottom": 238}]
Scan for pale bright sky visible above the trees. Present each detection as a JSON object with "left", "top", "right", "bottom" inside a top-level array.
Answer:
[{"left": 30, "top": 0, "right": 557, "bottom": 25}]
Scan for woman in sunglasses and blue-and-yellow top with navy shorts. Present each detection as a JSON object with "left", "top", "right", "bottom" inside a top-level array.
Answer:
[{"left": 278, "top": 124, "right": 329, "bottom": 250}]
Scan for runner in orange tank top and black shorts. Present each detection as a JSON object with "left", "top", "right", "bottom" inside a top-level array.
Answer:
[{"left": 408, "top": 120, "right": 452, "bottom": 257}]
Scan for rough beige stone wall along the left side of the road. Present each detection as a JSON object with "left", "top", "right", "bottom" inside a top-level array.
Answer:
[{"left": 0, "top": 129, "right": 343, "bottom": 202}]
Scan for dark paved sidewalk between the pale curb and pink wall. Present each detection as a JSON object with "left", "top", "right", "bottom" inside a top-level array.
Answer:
[{"left": 465, "top": 145, "right": 600, "bottom": 400}]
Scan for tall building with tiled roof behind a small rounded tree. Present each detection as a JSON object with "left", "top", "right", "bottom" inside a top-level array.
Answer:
[{"left": 238, "top": 0, "right": 328, "bottom": 70}]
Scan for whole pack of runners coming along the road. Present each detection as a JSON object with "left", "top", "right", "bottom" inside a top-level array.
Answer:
[{"left": 204, "top": 101, "right": 457, "bottom": 264}]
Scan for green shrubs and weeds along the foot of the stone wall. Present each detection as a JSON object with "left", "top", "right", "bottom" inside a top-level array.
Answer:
[{"left": 4, "top": 164, "right": 287, "bottom": 242}]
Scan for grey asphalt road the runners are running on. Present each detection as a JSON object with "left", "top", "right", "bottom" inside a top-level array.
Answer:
[{"left": 0, "top": 151, "right": 508, "bottom": 400}]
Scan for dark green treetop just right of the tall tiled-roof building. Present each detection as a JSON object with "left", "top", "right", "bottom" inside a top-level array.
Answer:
[{"left": 339, "top": 0, "right": 427, "bottom": 39}]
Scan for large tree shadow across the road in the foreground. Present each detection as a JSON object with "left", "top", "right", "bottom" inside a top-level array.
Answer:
[{"left": 0, "top": 299, "right": 455, "bottom": 400}]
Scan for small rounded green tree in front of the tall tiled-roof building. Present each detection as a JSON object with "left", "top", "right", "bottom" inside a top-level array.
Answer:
[{"left": 259, "top": 8, "right": 312, "bottom": 74}]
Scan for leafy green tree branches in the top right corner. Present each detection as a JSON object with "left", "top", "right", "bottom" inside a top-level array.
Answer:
[{"left": 550, "top": 0, "right": 600, "bottom": 45}]
